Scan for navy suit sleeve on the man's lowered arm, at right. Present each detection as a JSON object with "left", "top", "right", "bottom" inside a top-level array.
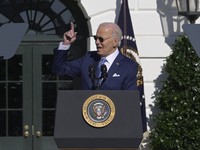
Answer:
[{"left": 123, "top": 63, "right": 138, "bottom": 90}]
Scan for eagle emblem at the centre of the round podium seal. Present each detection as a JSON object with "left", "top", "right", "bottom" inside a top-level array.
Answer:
[{"left": 92, "top": 104, "right": 107, "bottom": 119}]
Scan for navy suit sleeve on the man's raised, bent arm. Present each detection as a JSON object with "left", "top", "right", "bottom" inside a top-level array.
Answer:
[{"left": 52, "top": 48, "right": 81, "bottom": 77}]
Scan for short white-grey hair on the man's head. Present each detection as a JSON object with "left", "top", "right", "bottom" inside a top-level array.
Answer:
[{"left": 99, "top": 22, "right": 122, "bottom": 46}]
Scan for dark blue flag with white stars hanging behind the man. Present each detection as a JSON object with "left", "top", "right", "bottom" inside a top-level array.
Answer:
[{"left": 117, "top": 0, "right": 147, "bottom": 132}]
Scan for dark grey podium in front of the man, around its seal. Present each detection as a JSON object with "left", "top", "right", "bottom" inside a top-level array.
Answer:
[{"left": 54, "top": 90, "right": 143, "bottom": 150}]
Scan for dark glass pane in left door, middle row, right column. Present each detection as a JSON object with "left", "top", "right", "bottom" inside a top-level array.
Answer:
[{"left": 8, "top": 83, "right": 23, "bottom": 108}]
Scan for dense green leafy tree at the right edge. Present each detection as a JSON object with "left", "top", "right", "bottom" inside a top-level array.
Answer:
[{"left": 150, "top": 35, "right": 200, "bottom": 150}]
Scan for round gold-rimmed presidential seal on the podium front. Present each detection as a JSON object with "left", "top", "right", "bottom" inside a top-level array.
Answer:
[{"left": 82, "top": 94, "right": 115, "bottom": 127}]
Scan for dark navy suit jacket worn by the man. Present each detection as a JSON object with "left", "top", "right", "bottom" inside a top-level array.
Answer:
[{"left": 52, "top": 49, "right": 138, "bottom": 90}]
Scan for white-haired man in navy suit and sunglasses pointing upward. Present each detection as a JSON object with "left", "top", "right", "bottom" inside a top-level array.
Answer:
[{"left": 52, "top": 23, "right": 138, "bottom": 90}]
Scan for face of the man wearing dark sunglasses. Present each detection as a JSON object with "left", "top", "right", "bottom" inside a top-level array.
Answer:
[{"left": 95, "top": 26, "right": 117, "bottom": 57}]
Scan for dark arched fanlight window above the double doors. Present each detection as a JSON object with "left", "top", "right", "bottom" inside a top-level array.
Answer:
[{"left": 0, "top": 0, "right": 88, "bottom": 37}]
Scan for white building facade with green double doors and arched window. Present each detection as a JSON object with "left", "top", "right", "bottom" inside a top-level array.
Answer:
[{"left": 0, "top": 0, "right": 200, "bottom": 150}]
